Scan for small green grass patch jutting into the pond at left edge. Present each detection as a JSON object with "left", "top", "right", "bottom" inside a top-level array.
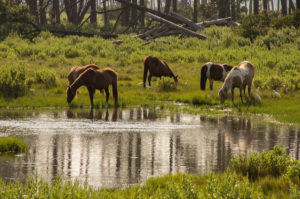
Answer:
[{"left": 0, "top": 137, "right": 26, "bottom": 153}]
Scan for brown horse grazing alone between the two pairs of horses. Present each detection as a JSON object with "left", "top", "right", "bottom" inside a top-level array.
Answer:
[{"left": 143, "top": 55, "right": 178, "bottom": 87}]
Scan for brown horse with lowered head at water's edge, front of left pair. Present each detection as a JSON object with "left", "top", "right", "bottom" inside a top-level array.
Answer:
[{"left": 67, "top": 68, "right": 118, "bottom": 108}]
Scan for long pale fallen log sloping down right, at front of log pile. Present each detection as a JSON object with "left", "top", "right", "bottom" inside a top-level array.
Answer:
[{"left": 146, "top": 13, "right": 206, "bottom": 39}]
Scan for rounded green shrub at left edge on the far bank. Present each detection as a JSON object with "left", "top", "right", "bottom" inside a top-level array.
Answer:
[{"left": 0, "top": 66, "right": 27, "bottom": 97}]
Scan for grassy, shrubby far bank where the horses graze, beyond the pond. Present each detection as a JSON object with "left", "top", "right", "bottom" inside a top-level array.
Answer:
[{"left": 0, "top": 27, "right": 300, "bottom": 123}]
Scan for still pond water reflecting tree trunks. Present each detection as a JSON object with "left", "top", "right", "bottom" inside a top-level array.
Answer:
[{"left": 0, "top": 108, "right": 300, "bottom": 187}]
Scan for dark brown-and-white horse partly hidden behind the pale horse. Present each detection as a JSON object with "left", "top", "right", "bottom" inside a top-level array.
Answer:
[{"left": 200, "top": 62, "right": 232, "bottom": 90}]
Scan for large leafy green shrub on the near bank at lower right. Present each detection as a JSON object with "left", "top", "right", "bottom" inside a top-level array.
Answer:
[{"left": 231, "top": 145, "right": 290, "bottom": 180}]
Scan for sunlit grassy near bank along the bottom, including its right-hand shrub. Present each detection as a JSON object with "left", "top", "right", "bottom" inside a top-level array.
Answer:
[{"left": 0, "top": 146, "right": 300, "bottom": 199}]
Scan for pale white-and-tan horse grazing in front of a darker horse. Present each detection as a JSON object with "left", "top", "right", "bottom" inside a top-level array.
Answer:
[{"left": 219, "top": 61, "right": 254, "bottom": 104}]
